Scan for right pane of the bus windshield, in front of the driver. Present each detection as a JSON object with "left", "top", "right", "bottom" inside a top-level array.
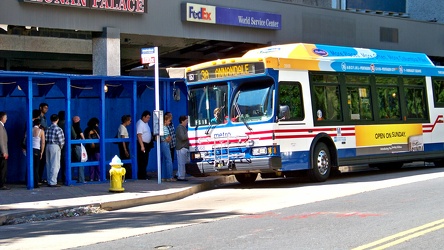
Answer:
[{"left": 231, "top": 81, "right": 273, "bottom": 122}]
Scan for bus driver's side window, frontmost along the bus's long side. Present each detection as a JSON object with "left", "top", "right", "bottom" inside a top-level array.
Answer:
[{"left": 277, "top": 82, "right": 304, "bottom": 121}]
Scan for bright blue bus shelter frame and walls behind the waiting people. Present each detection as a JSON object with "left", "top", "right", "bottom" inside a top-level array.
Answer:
[{"left": 0, "top": 71, "right": 187, "bottom": 189}]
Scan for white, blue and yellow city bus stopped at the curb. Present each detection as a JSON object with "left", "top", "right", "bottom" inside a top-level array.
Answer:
[{"left": 181, "top": 43, "right": 444, "bottom": 183}]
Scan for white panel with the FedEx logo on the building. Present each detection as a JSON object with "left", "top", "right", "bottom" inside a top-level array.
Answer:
[{"left": 182, "top": 3, "right": 216, "bottom": 23}]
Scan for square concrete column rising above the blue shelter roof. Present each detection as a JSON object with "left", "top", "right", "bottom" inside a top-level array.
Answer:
[{"left": 92, "top": 27, "right": 120, "bottom": 76}]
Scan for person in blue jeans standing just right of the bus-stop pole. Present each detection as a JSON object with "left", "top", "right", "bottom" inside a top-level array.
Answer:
[{"left": 160, "top": 113, "right": 176, "bottom": 181}]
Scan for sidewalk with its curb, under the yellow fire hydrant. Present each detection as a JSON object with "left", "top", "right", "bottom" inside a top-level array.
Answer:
[{"left": 0, "top": 176, "right": 236, "bottom": 225}]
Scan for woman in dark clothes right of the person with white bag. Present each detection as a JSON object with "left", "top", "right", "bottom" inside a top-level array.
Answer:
[{"left": 83, "top": 117, "right": 100, "bottom": 181}]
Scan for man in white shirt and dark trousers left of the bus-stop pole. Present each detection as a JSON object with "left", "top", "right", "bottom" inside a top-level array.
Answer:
[{"left": 136, "top": 110, "right": 153, "bottom": 180}]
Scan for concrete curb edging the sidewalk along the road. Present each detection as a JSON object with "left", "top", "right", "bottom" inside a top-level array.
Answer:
[{"left": 0, "top": 175, "right": 237, "bottom": 226}]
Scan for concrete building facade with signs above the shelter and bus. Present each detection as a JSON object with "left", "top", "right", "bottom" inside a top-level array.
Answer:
[{"left": 0, "top": 0, "right": 444, "bottom": 75}]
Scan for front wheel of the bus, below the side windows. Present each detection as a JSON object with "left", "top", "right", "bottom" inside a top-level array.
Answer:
[{"left": 308, "top": 142, "right": 331, "bottom": 182}]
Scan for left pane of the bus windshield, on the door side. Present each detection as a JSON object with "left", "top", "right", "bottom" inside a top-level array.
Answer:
[{"left": 188, "top": 83, "right": 228, "bottom": 127}]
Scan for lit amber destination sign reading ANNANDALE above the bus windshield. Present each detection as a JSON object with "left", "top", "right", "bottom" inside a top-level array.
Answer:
[{"left": 187, "top": 62, "right": 265, "bottom": 82}]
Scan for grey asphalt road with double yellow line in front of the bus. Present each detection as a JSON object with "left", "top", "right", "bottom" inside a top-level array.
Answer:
[{"left": 0, "top": 165, "right": 444, "bottom": 249}]
